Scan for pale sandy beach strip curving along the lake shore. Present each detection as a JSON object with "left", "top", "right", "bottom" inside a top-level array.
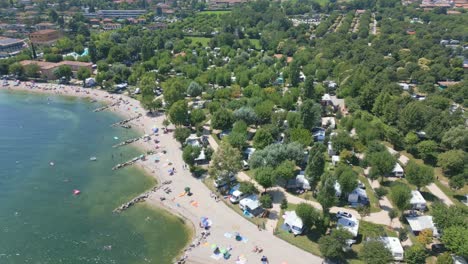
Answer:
[{"left": 0, "top": 83, "right": 322, "bottom": 264}]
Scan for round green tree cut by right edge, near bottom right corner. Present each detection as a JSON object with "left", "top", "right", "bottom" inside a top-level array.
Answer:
[{"left": 442, "top": 226, "right": 468, "bottom": 258}]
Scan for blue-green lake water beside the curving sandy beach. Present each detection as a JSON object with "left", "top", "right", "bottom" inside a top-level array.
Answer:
[{"left": 0, "top": 91, "right": 189, "bottom": 264}]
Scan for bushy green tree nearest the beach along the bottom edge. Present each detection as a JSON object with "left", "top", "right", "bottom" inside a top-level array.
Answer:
[{"left": 318, "top": 228, "right": 353, "bottom": 259}]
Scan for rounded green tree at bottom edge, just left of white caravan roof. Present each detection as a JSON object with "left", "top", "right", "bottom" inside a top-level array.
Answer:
[{"left": 359, "top": 240, "right": 393, "bottom": 264}]
